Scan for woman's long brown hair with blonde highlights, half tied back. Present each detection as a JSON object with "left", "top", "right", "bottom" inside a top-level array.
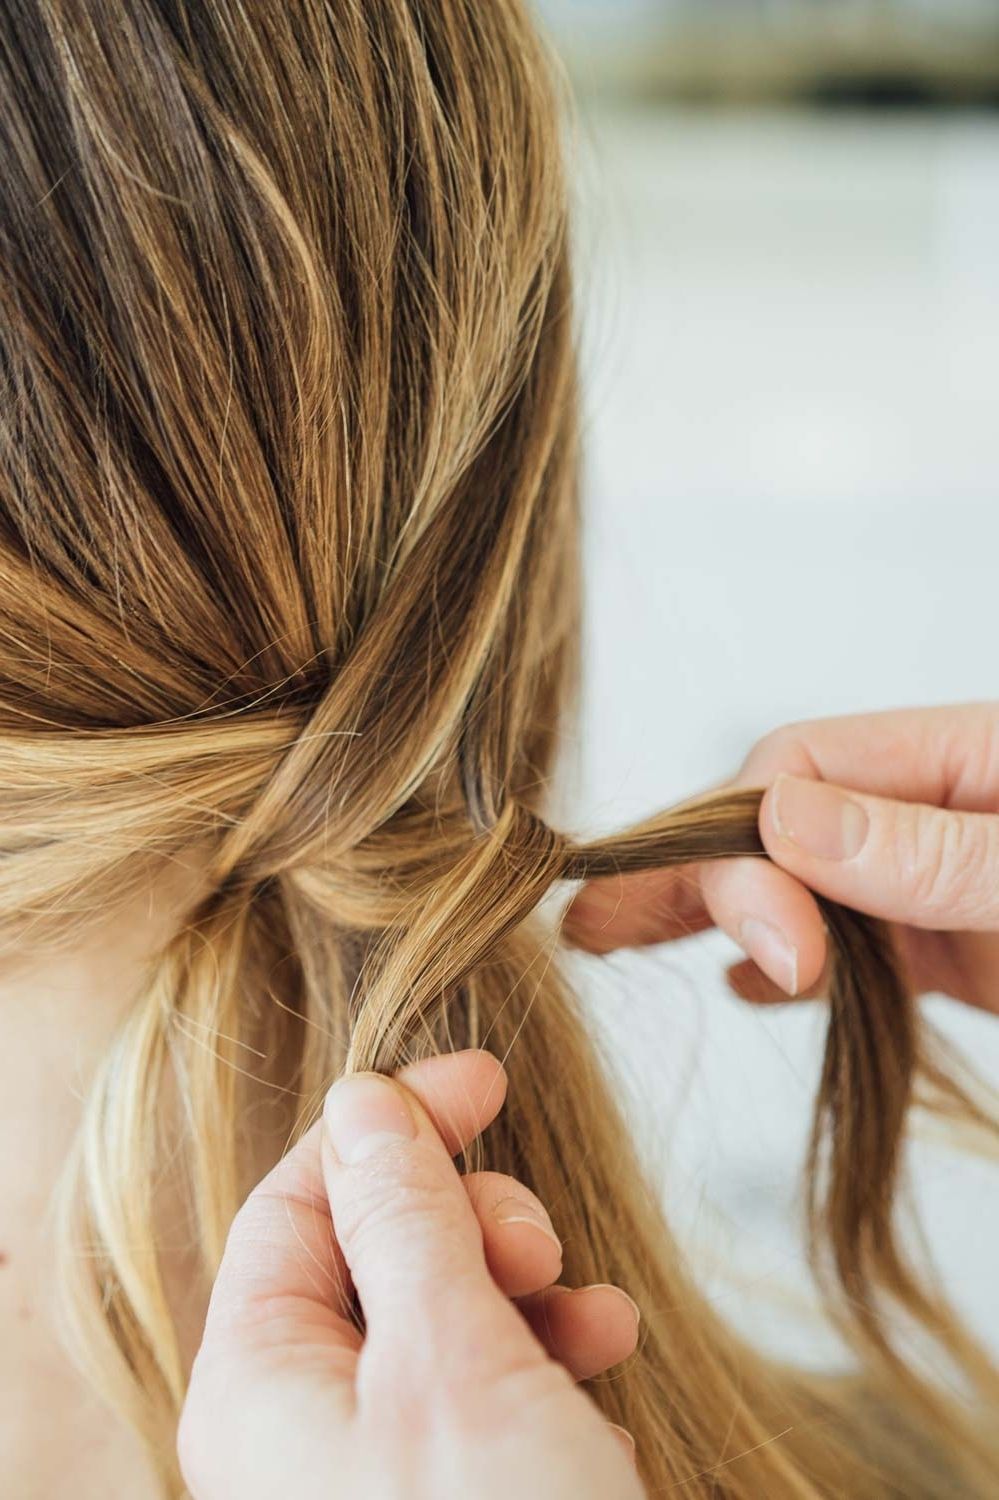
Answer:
[{"left": 0, "top": 0, "right": 998, "bottom": 1500}]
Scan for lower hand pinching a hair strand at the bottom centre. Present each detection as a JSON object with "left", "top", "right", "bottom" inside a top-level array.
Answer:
[{"left": 179, "top": 1052, "right": 644, "bottom": 1500}]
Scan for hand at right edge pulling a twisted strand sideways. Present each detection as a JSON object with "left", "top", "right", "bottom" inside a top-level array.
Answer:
[{"left": 566, "top": 704, "right": 999, "bottom": 1011}]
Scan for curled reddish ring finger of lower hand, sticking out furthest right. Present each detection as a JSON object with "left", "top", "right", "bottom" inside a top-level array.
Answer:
[{"left": 519, "top": 1286, "right": 639, "bottom": 1380}]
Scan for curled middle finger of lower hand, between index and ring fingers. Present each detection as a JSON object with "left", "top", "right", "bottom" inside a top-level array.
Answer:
[{"left": 462, "top": 1172, "right": 563, "bottom": 1298}]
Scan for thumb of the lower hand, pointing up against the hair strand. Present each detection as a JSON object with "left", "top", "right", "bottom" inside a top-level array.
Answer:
[{"left": 321, "top": 1073, "right": 545, "bottom": 1388}]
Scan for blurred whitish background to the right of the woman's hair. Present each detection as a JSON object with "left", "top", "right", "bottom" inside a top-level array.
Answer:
[{"left": 540, "top": 0, "right": 999, "bottom": 1364}]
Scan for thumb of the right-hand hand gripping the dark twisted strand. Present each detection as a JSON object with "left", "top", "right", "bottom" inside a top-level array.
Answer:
[{"left": 759, "top": 774, "right": 999, "bottom": 930}]
